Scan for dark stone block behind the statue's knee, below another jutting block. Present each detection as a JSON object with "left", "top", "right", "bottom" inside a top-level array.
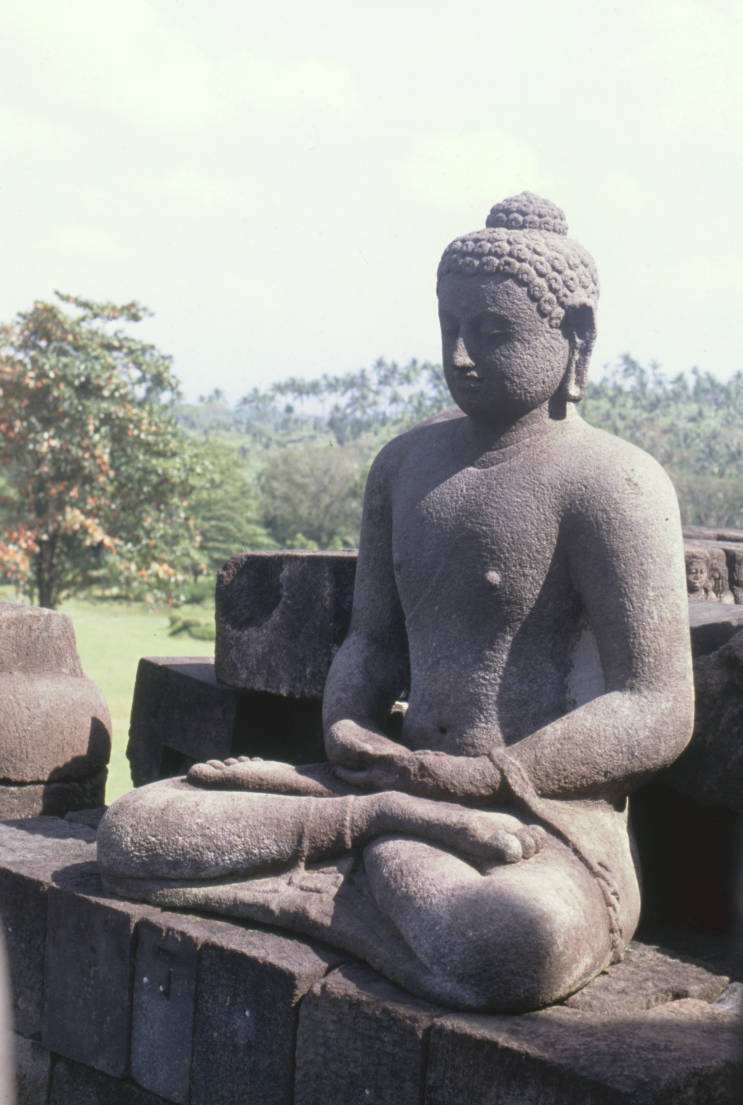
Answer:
[{"left": 127, "top": 656, "right": 325, "bottom": 787}]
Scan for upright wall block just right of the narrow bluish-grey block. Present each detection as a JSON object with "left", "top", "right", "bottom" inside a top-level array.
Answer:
[{"left": 191, "top": 923, "right": 341, "bottom": 1105}]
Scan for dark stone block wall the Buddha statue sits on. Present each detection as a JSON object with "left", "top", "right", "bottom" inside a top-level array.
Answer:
[{"left": 0, "top": 817, "right": 743, "bottom": 1105}]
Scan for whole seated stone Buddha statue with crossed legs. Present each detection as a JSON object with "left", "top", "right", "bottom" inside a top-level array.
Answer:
[{"left": 98, "top": 192, "right": 692, "bottom": 1011}]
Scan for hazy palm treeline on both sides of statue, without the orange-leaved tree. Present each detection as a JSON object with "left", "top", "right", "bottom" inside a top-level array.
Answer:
[{"left": 176, "top": 356, "right": 743, "bottom": 567}]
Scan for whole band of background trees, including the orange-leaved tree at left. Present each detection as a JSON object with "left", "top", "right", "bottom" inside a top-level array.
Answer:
[{"left": 0, "top": 293, "right": 743, "bottom": 614}]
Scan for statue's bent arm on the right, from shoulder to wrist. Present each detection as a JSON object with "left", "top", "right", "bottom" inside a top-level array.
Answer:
[{"left": 509, "top": 446, "right": 693, "bottom": 799}]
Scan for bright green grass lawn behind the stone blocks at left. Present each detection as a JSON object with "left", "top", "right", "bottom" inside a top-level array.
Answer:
[{"left": 0, "top": 588, "right": 214, "bottom": 803}]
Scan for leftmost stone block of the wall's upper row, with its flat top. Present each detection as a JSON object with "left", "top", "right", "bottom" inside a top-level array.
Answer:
[{"left": 0, "top": 818, "right": 95, "bottom": 1036}]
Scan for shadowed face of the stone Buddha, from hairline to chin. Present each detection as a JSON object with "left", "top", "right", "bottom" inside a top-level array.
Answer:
[{"left": 439, "top": 273, "right": 571, "bottom": 427}]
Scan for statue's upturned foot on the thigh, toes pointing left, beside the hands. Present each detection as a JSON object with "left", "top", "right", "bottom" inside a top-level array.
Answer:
[{"left": 187, "top": 756, "right": 358, "bottom": 798}]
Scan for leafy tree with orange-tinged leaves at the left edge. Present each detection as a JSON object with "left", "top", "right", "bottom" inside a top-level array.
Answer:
[{"left": 0, "top": 293, "right": 199, "bottom": 607}]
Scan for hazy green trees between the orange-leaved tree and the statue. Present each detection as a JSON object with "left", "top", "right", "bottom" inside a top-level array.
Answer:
[{"left": 176, "top": 359, "right": 451, "bottom": 552}]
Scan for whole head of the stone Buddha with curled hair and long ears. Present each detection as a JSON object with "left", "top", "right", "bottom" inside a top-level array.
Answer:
[{"left": 437, "top": 192, "right": 598, "bottom": 425}]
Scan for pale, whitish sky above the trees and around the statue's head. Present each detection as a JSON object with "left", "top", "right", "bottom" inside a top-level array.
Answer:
[{"left": 0, "top": 0, "right": 743, "bottom": 399}]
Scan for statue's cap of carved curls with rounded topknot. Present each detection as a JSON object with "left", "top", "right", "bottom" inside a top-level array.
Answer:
[{"left": 437, "top": 192, "right": 598, "bottom": 329}]
